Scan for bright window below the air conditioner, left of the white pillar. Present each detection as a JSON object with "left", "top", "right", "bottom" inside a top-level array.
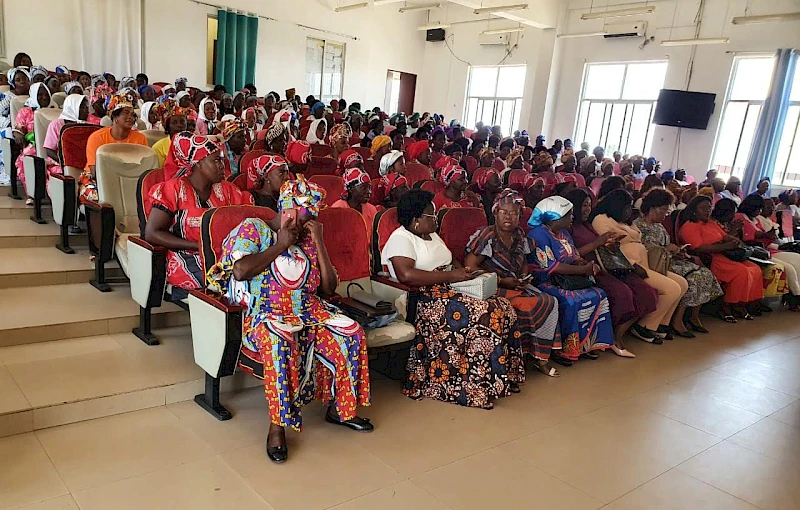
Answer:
[{"left": 464, "top": 66, "right": 526, "bottom": 135}]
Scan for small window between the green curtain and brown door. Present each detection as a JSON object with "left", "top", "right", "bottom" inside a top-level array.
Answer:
[{"left": 306, "top": 37, "right": 344, "bottom": 103}]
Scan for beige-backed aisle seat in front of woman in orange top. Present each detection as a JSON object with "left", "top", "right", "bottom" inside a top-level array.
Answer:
[{"left": 84, "top": 143, "right": 158, "bottom": 292}]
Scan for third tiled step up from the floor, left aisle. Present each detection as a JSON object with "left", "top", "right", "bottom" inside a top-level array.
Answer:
[{"left": 0, "top": 247, "right": 124, "bottom": 289}]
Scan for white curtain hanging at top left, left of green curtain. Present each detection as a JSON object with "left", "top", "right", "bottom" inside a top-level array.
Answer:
[{"left": 74, "top": 0, "right": 143, "bottom": 76}]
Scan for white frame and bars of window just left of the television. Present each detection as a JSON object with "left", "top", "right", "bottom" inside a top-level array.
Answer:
[{"left": 572, "top": 59, "right": 669, "bottom": 156}]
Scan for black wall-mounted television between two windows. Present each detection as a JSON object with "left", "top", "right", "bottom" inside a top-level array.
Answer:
[{"left": 653, "top": 89, "right": 717, "bottom": 129}]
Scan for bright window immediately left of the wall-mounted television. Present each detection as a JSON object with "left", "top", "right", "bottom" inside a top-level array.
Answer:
[{"left": 575, "top": 62, "right": 667, "bottom": 156}]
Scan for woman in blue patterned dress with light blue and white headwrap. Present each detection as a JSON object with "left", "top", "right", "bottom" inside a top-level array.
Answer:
[{"left": 528, "top": 196, "right": 614, "bottom": 358}]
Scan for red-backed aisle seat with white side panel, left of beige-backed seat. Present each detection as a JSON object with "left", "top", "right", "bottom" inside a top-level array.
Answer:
[{"left": 50, "top": 124, "right": 100, "bottom": 254}]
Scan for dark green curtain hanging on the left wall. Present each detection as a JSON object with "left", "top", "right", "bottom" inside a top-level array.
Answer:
[{"left": 214, "top": 10, "right": 258, "bottom": 93}]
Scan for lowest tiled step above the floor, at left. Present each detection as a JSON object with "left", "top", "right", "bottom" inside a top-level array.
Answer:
[{"left": 0, "top": 326, "right": 261, "bottom": 437}]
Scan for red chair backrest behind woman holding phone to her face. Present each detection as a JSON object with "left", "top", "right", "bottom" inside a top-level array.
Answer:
[{"left": 200, "top": 205, "right": 276, "bottom": 274}]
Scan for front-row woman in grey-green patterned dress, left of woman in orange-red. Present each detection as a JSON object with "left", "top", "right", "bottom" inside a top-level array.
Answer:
[{"left": 634, "top": 188, "right": 724, "bottom": 338}]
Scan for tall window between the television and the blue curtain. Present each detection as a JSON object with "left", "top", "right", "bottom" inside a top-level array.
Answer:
[{"left": 711, "top": 56, "right": 780, "bottom": 179}]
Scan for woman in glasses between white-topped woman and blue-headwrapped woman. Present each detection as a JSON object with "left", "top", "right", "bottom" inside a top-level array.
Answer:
[{"left": 464, "top": 189, "right": 561, "bottom": 377}]
